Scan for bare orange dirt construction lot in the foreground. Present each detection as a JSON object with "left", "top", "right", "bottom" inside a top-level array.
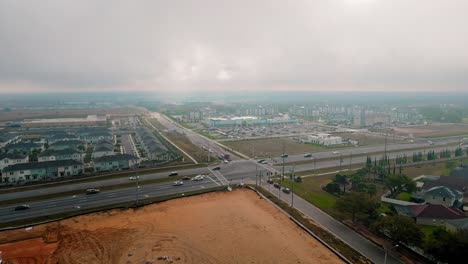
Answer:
[{"left": 0, "top": 190, "right": 342, "bottom": 264}]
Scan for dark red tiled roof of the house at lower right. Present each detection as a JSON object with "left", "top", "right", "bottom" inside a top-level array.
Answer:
[{"left": 411, "top": 204, "right": 465, "bottom": 219}]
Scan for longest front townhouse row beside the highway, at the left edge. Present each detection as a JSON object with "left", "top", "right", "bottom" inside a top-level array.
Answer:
[{"left": 2, "top": 160, "right": 83, "bottom": 182}]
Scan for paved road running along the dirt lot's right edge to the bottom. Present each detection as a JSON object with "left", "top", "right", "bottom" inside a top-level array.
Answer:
[{"left": 261, "top": 182, "right": 401, "bottom": 264}]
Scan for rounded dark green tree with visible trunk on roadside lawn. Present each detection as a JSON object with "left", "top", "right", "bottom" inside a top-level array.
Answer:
[{"left": 335, "top": 192, "right": 375, "bottom": 223}]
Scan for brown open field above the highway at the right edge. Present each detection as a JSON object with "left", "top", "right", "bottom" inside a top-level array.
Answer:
[{"left": 394, "top": 123, "right": 468, "bottom": 138}]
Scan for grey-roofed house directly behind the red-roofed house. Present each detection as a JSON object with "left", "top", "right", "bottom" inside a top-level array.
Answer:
[{"left": 423, "top": 186, "right": 463, "bottom": 207}]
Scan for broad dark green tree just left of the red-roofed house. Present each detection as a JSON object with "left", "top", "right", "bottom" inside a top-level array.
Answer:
[{"left": 371, "top": 215, "right": 424, "bottom": 246}]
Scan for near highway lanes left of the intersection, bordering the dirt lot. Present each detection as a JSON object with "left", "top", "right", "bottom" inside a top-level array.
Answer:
[{"left": 0, "top": 177, "right": 220, "bottom": 223}]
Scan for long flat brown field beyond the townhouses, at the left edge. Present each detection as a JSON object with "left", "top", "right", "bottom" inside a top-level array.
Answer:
[{"left": 0, "top": 107, "right": 145, "bottom": 122}]
